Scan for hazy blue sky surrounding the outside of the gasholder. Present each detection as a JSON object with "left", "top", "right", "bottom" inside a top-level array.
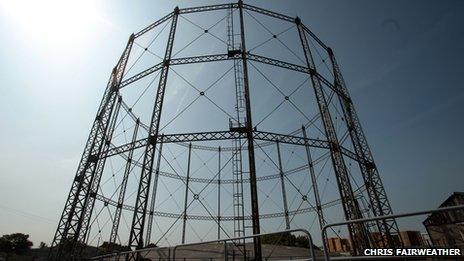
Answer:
[{"left": 0, "top": 0, "right": 464, "bottom": 245}]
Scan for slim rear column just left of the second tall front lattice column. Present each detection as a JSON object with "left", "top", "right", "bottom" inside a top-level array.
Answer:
[{"left": 109, "top": 119, "right": 140, "bottom": 246}]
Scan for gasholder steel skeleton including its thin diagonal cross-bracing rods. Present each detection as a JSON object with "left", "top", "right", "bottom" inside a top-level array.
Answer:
[{"left": 50, "top": 1, "right": 398, "bottom": 260}]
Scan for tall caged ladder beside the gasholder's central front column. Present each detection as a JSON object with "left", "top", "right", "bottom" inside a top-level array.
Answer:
[{"left": 227, "top": 8, "right": 246, "bottom": 260}]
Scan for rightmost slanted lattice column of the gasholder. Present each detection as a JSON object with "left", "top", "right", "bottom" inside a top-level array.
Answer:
[{"left": 327, "top": 48, "right": 400, "bottom": 247}]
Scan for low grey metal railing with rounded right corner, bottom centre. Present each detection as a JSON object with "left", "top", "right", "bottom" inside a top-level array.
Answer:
[{"left": 90, "top": 229, "right": 316, "bottom": 260}]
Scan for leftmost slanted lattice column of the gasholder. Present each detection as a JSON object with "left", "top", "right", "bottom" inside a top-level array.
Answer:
[{"left": 49, "top": 35, "right": 134, "bottom": 260}]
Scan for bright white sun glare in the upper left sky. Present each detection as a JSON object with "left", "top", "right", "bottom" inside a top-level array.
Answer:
[{"left": 0, "top": 0, "right": 97, "bottom": 43}]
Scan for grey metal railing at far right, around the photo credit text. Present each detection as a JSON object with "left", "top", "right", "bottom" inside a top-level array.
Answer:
[{"left": 321, "top": 205, "right": 464, "bottom": 260}]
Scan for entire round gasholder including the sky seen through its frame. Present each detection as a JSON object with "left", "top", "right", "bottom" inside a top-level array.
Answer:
[{"left": 50, "top": 2, "right": 399, "bottom": 260}]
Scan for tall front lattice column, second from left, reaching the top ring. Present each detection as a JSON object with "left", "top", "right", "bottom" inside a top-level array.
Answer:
[{"left": 129, "top": 7, "right": 179, "bottom": 252}]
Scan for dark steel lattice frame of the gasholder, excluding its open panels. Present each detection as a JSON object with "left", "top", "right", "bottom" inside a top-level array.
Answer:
[{"left": 50, "top": 1, "right": 398, "bottom": 260}]
